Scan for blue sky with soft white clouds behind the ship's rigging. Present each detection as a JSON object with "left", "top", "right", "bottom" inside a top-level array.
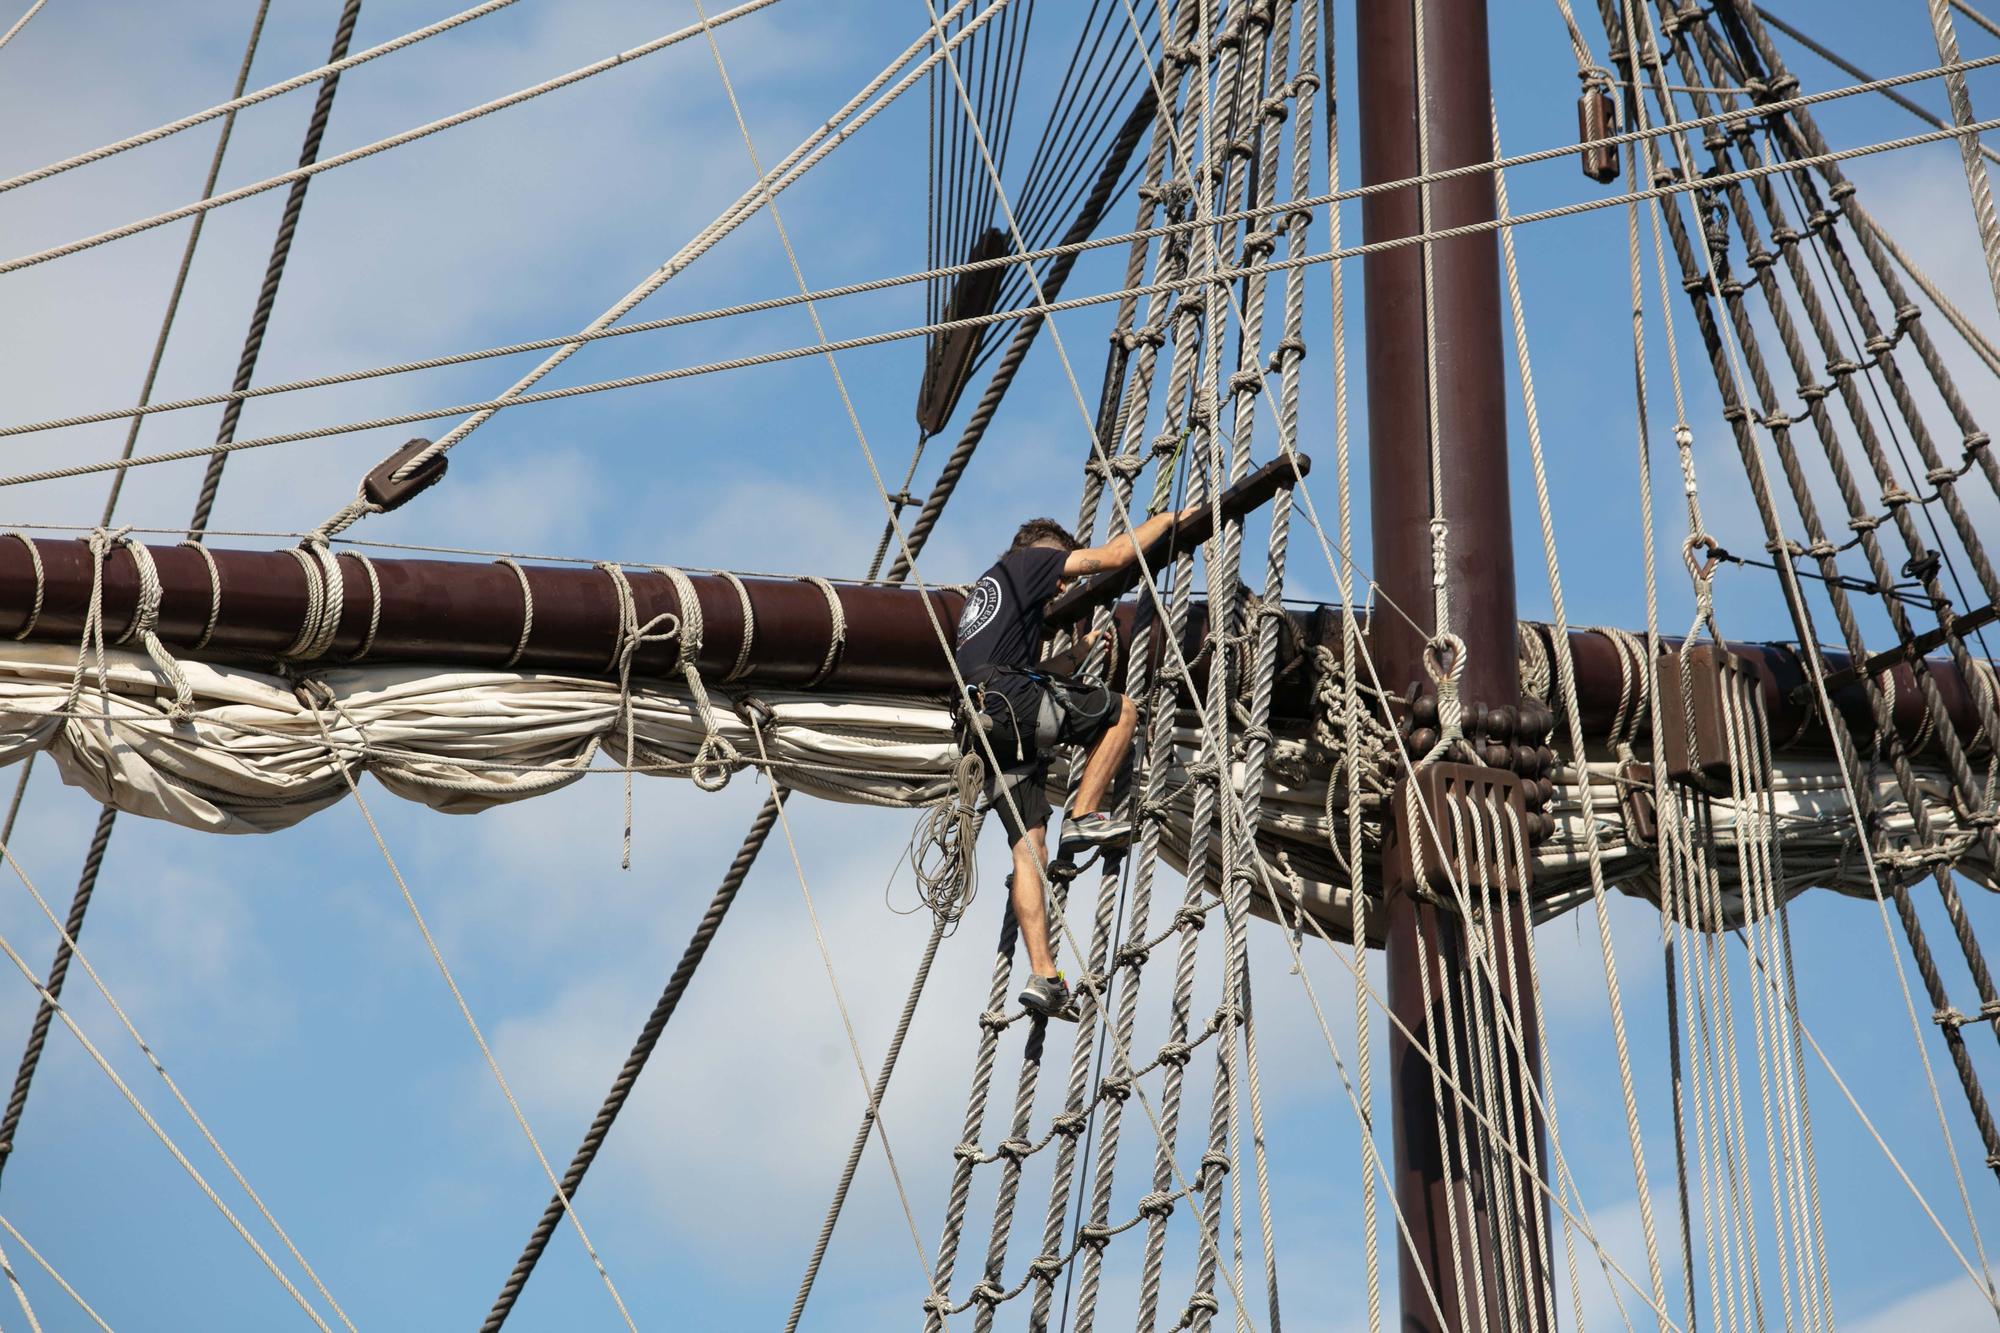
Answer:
[{"left": 0, "top": 0, "right": 2000, "bottom": 1329}]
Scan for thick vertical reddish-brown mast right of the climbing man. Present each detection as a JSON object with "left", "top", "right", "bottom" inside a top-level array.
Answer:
[{"left": 1356, "top": 0, "right": 1546, "bottom": 1333}]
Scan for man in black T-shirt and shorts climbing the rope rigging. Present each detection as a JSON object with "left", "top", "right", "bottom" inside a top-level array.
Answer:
[{"left": 958, "top": 506, "right": 1198, "bottom": 1017}]
